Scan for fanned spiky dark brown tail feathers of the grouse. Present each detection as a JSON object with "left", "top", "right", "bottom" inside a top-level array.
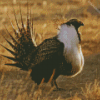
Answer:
[{"left": 1, "top": 2, "right": 37, "bottom": 70}]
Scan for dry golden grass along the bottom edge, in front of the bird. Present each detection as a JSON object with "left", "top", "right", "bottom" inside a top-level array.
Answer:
[{"left": 0, "top": 70, "right": 100, "bottom": 100}]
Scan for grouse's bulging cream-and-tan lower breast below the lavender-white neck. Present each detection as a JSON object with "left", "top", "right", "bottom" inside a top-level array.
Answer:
[{"left": 63, "top": 47, "right": 84, "bottom": 77}]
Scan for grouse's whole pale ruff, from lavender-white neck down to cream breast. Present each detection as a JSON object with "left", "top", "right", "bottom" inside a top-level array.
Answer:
[{"left": 58, "top": 25, "right": 84, "bottom": 77}]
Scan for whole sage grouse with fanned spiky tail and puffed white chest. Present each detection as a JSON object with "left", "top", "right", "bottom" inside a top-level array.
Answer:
[{"left": 1, "top": 4, "right": 84, "bottom": 89}]
